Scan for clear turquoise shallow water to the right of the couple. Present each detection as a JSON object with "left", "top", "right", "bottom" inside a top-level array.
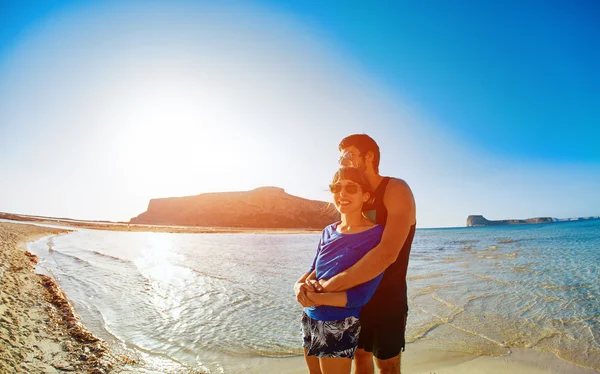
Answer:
[{"left": 409, "top": 221, "right": 600, "bottom": 370}]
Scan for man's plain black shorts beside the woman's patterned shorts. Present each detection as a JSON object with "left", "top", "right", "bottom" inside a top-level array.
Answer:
[{"left": 358, "top": 311, "right": 408, "bottom": 360}]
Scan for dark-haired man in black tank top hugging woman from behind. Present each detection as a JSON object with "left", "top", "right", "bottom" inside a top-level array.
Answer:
[{"left": 295, "top": 134, "right": 416, "bottom": 374}]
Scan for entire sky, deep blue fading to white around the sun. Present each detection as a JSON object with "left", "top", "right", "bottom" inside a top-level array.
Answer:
[{"left": 0, "top": 1, "right": 600, "bottom": 227}]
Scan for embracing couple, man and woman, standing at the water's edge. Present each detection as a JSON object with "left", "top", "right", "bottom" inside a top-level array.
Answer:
[{"left": 294, "top": 134, "right": 416, "bottom": 374}]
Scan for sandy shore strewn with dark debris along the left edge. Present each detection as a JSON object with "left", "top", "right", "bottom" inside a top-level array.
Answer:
[{"left": 0, "top": 222, "right": 124, "bottom": 373}]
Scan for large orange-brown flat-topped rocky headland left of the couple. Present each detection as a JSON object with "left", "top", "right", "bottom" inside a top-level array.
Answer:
[{"left": 131, "top": 187, "right": 339, "bottom": 229}]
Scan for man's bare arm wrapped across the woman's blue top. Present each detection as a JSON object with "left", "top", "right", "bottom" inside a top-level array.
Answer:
[{"left": 317, "top": 179, "right": 415, "bottom": 292}]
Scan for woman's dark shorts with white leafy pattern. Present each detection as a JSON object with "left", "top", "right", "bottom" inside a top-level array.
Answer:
[{"left": 302, "top": 312, "right": 360, "bottom": 359}]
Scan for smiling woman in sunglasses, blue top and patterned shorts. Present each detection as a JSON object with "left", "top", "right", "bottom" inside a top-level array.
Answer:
[{"left": 294, "top": 168, "right": 383, "bottom": 374}]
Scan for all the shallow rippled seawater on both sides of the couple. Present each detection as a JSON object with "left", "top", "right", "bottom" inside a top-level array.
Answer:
[{"left": 30, "top": 221, "right": 600, "bottom": 372}]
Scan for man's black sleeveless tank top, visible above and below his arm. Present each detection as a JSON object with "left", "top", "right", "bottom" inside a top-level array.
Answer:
[{"left": 363, "top": 177, "right": 415, "bottom": 313}]
